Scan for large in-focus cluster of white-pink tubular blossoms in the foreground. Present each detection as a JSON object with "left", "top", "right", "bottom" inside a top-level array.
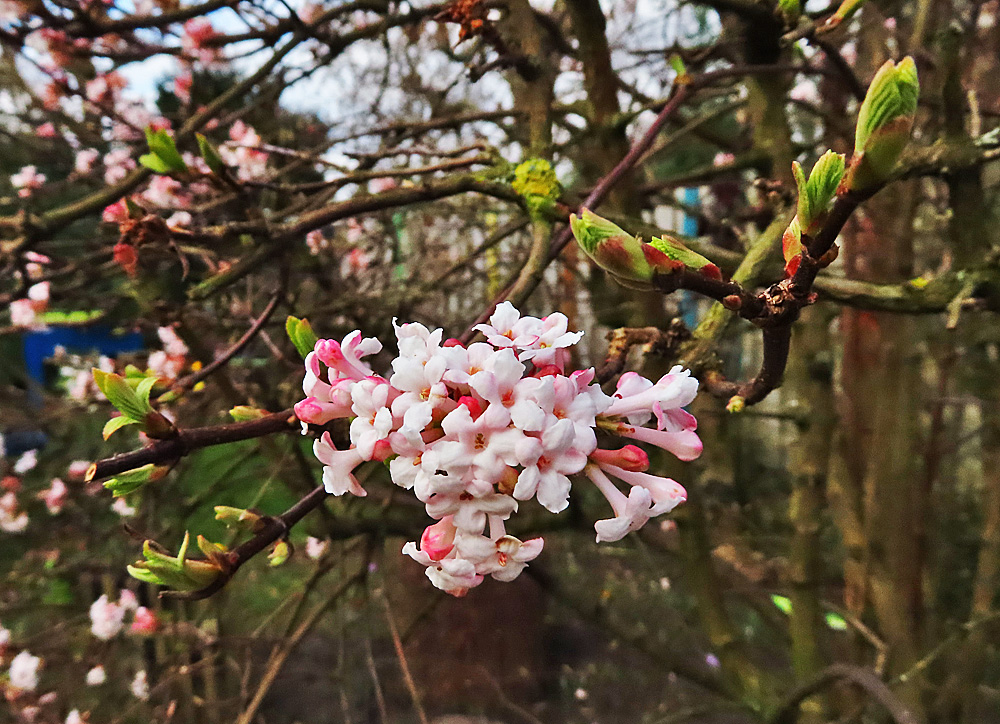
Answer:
[{"left": 295, "top": 302, "right": 701, "bottom": 596}]
